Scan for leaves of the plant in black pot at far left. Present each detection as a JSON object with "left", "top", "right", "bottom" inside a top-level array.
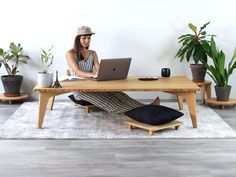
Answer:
[{"left": 0, "top": 42, "right": 29, "bottom": 75}]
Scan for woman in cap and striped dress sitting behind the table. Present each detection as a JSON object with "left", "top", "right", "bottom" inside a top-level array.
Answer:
[{"left": 66, "top": 26, "right": 160, "bottom": 113}]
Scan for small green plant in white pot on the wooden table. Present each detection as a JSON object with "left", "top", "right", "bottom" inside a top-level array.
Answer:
[{"left": 38, "top": 46, "right": 54, "bottom": 87}]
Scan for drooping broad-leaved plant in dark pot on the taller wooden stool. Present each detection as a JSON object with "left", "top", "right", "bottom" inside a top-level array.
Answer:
[{"left": 175, "top": 22, "right": 214, "bottom": 82}]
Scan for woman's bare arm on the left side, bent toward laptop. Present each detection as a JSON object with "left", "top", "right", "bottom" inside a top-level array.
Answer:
[{"left": 66, "top": 50, "right": 97, "bottom": 77}]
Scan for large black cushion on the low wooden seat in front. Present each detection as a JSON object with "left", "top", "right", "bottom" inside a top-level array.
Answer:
[{"left": 124, "top": 105, "right": 184, "bottom": 125}]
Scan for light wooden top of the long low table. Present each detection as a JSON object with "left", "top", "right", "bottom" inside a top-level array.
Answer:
[{"left": 34, "top": 76, "right": 200, "bottom": 93}]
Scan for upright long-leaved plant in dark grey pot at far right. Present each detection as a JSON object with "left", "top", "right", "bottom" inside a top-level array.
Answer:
[{"left": 202, "top": 37, "right": 236, "bottom": 101}]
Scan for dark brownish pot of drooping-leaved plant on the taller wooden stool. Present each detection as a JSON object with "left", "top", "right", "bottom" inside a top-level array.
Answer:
[{"left": 190, "top": 64, "right": 206, "bottom": 82}]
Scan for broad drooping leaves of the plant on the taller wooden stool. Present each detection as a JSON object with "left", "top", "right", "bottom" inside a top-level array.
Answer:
[{"left": 175, "top": 22, "right": 214, "bottom": 64}]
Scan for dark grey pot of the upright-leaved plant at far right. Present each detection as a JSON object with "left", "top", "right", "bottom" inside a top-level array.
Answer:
[{"left": 215, "top": 85, "right": 231, "bottom": 101}]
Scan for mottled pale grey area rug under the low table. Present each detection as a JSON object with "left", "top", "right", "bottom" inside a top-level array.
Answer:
[{"left": 0, "top": 102, "right": 236, "bottom": 139}]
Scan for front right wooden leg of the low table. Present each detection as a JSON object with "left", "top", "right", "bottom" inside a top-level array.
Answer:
[{"left": 186, "top": 92, "right": 197, "bottom": 128}]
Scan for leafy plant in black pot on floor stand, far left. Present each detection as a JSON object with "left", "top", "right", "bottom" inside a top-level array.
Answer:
[{"left": 0, "top": 42, "right": 29, "bottom": 96}]
